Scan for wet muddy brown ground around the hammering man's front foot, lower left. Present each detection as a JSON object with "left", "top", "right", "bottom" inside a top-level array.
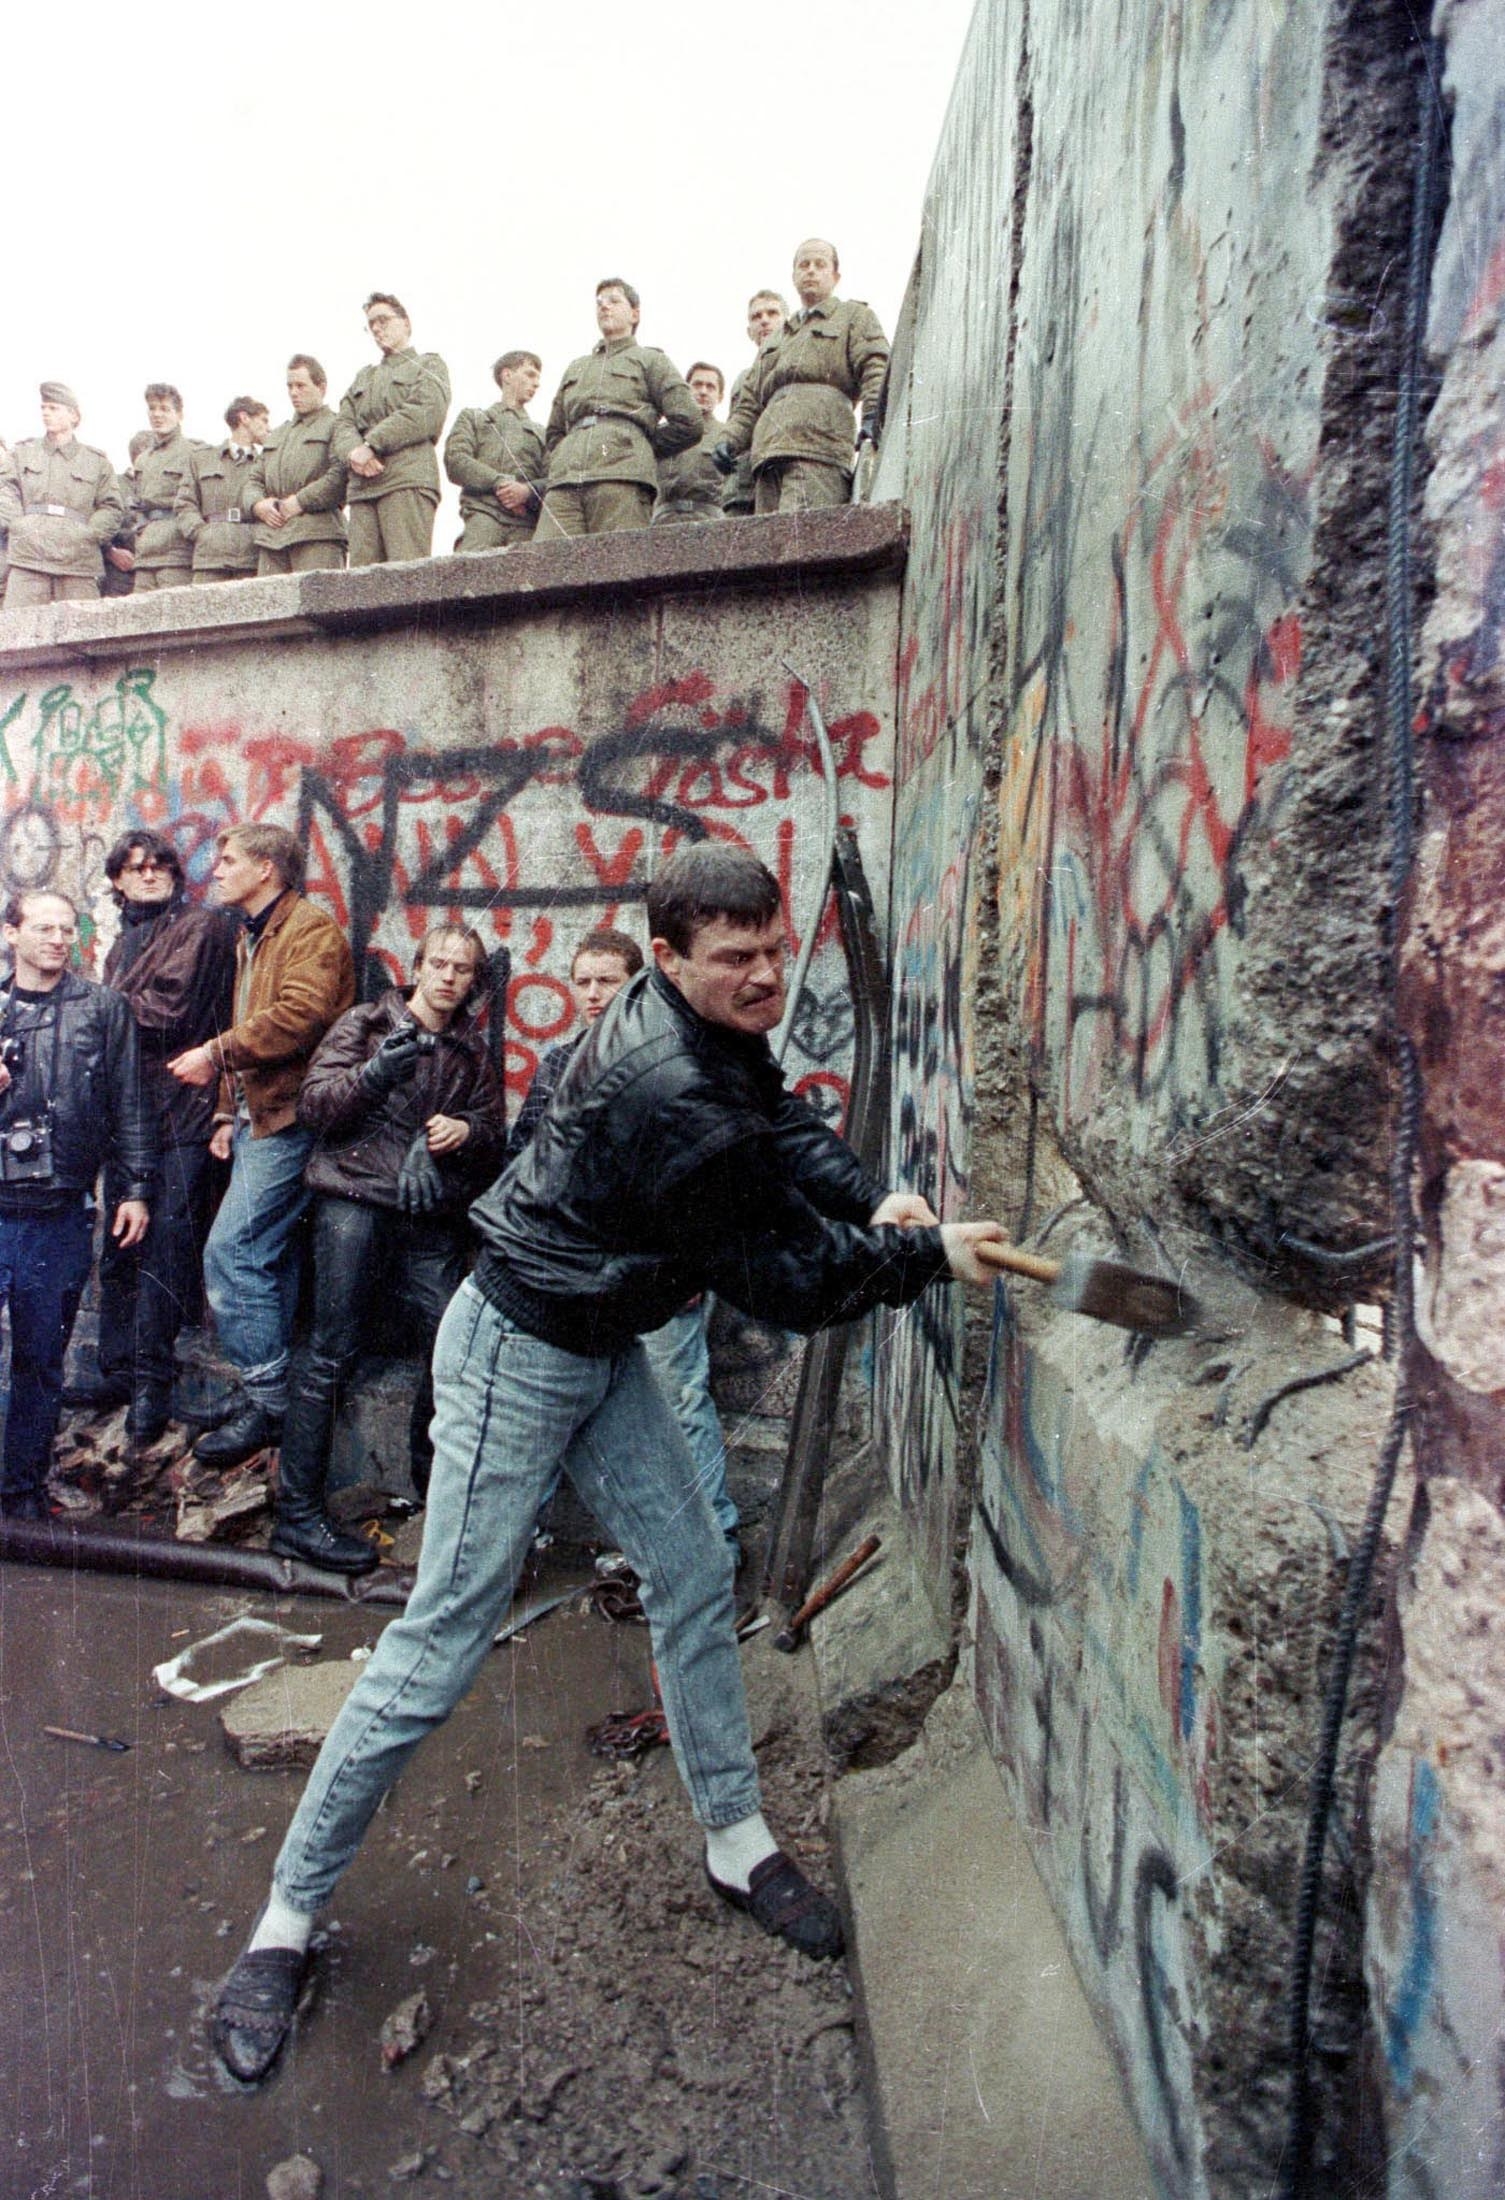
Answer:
[{"left": 0, "top": 1566, "right": 649, "bottom": 2200}]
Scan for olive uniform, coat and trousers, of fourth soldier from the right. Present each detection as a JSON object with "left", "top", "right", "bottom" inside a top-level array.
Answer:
[{"left": 539, "top": 337, "right": 704, "bottom": 541}]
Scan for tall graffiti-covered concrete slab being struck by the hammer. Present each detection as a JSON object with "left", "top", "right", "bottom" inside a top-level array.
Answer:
[{"left": 882, "top": 0, "right": 1417, "bottom": 2196}]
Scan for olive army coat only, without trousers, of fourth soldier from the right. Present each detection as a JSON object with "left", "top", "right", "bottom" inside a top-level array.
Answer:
[{"left": 543, "top": 337, "right": 702, "bottom": 488}]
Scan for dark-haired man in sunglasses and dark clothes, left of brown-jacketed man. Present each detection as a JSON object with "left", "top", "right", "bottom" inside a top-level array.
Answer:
[{"left": 68, "top": 832, "right": 235, "bottom": 1445}]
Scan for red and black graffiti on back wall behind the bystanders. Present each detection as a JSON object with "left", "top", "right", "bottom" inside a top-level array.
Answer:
[{"left": 0, "top": 669, "right": 889, "bottom": 1115}]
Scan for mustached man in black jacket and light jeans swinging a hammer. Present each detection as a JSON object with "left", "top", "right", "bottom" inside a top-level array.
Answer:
[{"left": 213, "top": 843, "right": 999, "bottom": 2079}]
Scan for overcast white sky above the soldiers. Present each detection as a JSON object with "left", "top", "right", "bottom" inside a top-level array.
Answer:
[{"left": 0, "top": 0, "right": 973, "bottom": 532}]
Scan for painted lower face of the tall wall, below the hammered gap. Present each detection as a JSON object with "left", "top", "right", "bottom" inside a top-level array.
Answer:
[{"left": 973, "top": 1294, "right": 1219, "bottom": 2191}]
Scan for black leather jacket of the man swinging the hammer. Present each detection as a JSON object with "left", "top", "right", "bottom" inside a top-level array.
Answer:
[{"left": 471, "top": 970, "right": 946, "bottom": 1355}]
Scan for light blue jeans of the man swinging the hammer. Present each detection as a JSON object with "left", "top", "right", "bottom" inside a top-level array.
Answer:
[{"left": 275, "top": 1283, "right": 759, "bottom": 1910}]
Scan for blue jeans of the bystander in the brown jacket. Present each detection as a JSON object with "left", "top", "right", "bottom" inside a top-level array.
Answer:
[{"left": 205, "top": 1115, "right": 312, "bottom": 1415}]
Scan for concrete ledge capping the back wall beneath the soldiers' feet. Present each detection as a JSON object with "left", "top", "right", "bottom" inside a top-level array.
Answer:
[{"left": 0, "top": 504, "right": 909, "bottom": 669}]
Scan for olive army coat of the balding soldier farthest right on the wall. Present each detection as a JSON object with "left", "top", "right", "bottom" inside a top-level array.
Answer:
[{"left": 726, "top": 297, "right": 889, "bottom": 473}]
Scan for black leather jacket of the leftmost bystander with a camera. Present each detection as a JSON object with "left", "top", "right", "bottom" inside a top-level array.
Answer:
[{"left": 0, "top": 970, "right": 158, "bottom": 1208}]
